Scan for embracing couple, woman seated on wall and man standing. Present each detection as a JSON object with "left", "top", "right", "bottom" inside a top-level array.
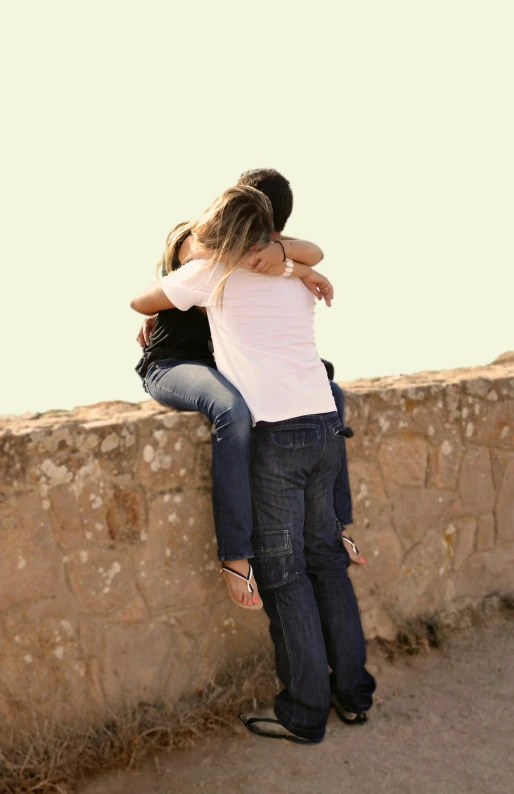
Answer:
[{"left": 131, "top": 169, "right": 375, "bottom": 743}]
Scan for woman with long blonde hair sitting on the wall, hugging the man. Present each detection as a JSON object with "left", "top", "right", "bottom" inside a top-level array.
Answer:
[{"left": 131, "top": 173, "right": 358, "bottom": 609}]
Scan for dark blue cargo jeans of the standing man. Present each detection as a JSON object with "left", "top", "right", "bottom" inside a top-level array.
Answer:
[{"left": 251, "top": 412, "right": 375, "bottom": 741}]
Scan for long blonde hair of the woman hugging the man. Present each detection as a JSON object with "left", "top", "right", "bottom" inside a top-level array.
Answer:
[{"left": 164, "top": 185, "right": 273, "bottom": 303}]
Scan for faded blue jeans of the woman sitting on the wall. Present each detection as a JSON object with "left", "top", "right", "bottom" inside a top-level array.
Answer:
[{"left": 145, "top": 358, "right": 352, "bottom": 561}]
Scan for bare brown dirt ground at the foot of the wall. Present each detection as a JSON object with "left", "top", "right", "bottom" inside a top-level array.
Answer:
[{"left": 81, "top": 618, "right": 514, "bottom": 794}]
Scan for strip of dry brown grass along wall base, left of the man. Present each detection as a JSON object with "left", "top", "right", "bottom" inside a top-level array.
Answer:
[{"left": 0, "top": 654, "right": 278, "bottom": 794}]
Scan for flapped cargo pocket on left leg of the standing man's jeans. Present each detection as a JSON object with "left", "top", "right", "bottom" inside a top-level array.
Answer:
[{"left": 252, "top": 524, "right": 294, "bottom": 590}]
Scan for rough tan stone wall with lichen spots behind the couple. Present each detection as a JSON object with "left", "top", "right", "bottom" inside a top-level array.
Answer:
[{"left": 0, "top": 356, "right": 514, "bottom": 720}]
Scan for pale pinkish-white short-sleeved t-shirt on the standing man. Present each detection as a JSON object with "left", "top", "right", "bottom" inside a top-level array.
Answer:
[{"left": 160, "top": 259, "right": 336, "bottom": 422}]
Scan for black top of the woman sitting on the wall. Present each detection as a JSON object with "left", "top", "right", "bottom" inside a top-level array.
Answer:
[{"left": 136, "top": 234, "right": 214, "bottom": 378}]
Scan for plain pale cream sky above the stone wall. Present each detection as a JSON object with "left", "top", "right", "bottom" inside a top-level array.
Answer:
[{"left": 0, "top": 0, "right": 514, "bottom": 413}]
